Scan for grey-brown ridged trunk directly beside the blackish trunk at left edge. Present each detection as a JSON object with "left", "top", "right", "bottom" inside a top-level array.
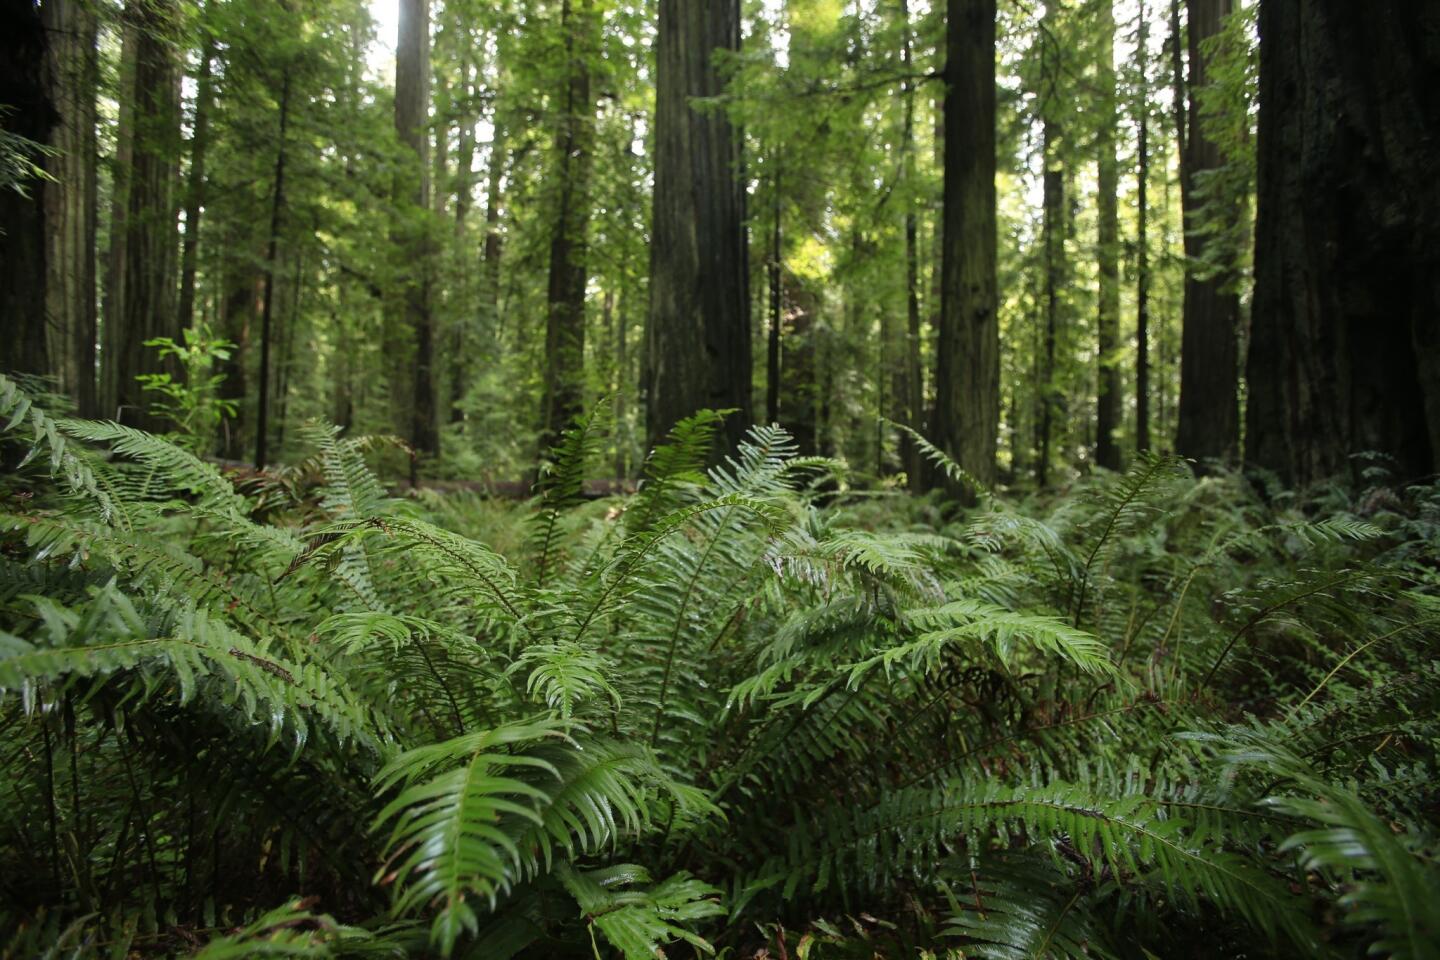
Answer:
[{"left": 40, "top": 0, "right": 99, "bottom": 417}]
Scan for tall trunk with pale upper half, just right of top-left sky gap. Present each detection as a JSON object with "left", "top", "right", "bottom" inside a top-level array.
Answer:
[{"left": 395, "top": 0, "right": 441, "bottom": 485}]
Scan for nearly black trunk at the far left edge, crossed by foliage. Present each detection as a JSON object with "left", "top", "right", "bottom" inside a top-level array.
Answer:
[{"left": 0, "top": 3, "right": 54, "bottom": 376}]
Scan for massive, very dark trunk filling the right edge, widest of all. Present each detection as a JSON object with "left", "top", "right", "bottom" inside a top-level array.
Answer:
[{"left": 1246, "top": 0, "right": 1440, "bottom": 485}]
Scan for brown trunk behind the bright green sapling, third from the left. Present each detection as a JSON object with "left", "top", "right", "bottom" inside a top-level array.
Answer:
[{"left": 105, "top": 0, "right": 180, "bottom": 430}]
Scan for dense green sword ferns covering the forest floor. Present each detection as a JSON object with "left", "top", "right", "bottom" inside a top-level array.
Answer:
[{"left": 0, "top": 381, "right": 1440, "bottom": 957}]
